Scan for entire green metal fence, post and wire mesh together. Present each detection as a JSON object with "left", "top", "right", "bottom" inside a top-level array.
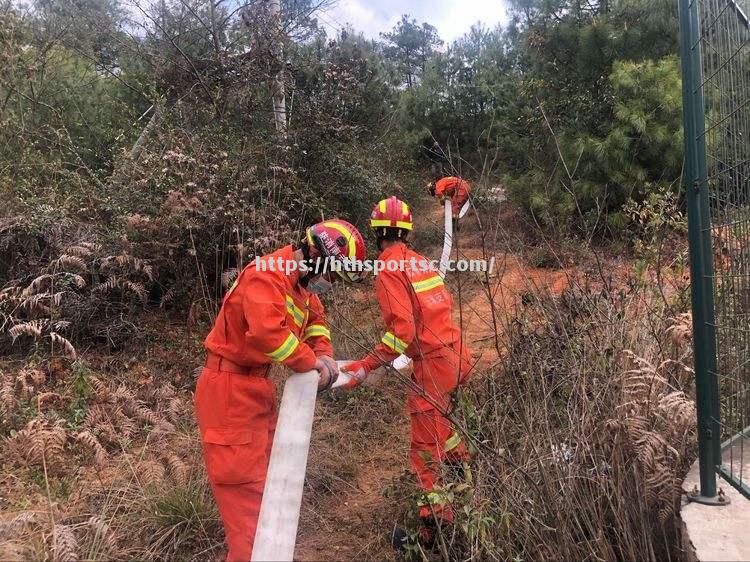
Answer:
[{"left": 679, "top": 0, "right": 750, "bottom": 503}]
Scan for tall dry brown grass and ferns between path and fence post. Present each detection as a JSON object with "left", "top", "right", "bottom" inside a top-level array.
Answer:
[{"left": 413, "top": 280, "right": 695, "bottom": 561}]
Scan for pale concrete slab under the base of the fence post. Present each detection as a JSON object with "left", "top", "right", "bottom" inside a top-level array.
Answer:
[{"left": 681, "top": 437, "right": 750, "bottom": 562}]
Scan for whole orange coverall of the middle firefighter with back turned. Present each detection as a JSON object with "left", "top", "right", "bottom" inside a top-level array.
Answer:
[{"left": 363, "top": 242, "right": 472, "bottom": 520}]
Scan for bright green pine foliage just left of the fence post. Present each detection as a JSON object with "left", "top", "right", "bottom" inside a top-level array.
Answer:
[{"left": 509, "top": 57, "right": 683, "bottom": 232}]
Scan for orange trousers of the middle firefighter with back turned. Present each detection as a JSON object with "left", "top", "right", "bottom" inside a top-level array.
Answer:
[{"left": 407, "top": 349, "right": 469, "bottom": 519}]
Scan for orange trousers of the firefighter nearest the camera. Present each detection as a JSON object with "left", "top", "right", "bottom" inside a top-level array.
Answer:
[{"left": 195, "top": 369, "right": 276, "bottom": 561}]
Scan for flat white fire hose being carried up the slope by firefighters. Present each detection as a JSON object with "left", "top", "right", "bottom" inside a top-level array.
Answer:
[{"left": 252, "top": 200, "right": 458, "bottom": 562}]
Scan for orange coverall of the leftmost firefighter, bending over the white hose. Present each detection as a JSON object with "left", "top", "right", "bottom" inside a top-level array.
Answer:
[{"left": 195, "top": 246, "right": 333, "bottom": 561}]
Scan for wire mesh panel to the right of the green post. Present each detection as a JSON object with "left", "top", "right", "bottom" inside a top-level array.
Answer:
[{"left": 683, "top": 0, "right": 750, "bottom": 497}]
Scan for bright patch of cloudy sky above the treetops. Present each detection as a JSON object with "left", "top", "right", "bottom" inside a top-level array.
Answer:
[{"left": 318, "top": 0, "right": 507, "bottom": 43}]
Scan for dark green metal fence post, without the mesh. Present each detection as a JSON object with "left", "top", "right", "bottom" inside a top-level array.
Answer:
[{"left": 679, "top": 0, "right": 726, "bottom": 505}]
